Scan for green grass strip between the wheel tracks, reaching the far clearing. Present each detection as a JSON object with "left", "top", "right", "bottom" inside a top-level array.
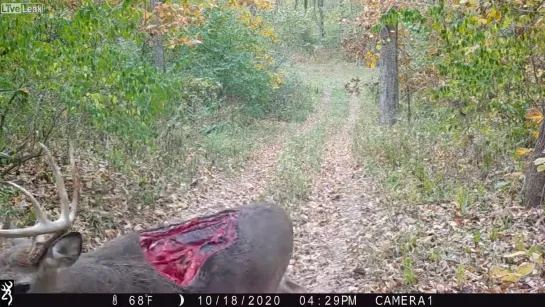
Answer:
[{"left": 266, "top": 59, "right": 369, "bottom": 206}]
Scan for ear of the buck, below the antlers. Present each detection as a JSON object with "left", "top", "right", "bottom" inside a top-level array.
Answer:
[{"left": 43, "top": 232, "right": 83, "bottom": 268}]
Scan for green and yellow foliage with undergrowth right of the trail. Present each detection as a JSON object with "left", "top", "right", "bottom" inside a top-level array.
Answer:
[{"left": 347, "top": 1, "right": 545, "bottom": 211}]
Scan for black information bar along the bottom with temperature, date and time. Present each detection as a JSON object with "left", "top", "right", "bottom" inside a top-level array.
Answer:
[{"left": 6, "top": 293, "right": 545, "bottom": 307}]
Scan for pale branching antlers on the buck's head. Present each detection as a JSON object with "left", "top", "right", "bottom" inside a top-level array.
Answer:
[{"left": 0, "top": 142, "right": 79, "bottom": 238}]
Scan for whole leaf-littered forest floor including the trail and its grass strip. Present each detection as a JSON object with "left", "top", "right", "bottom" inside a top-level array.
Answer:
[{"left": 2, "top": 63, "right": 545, "bottom": 292}]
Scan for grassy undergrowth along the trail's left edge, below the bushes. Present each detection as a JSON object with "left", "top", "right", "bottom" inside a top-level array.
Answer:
[{"left": 117, "top": 71, "right": 316, "bottom": 192}]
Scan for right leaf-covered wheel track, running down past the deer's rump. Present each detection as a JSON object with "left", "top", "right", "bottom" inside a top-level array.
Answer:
[{"left": 290, "top": 92, "right": 364, "bottom": 292}]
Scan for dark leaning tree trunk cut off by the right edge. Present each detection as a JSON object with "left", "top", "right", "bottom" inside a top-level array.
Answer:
[{"left": 522, "top": 122, "right": 545, "bottom": 207}]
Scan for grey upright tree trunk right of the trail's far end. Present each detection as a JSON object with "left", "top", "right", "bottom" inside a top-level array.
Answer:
[{"left": 379, "top": 24, "right": 399, "bottom": 125}]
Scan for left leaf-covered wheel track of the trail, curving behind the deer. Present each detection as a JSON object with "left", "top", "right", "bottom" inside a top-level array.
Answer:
[{"left": 172, "top": 92, "right": 329, "bottom": 223}]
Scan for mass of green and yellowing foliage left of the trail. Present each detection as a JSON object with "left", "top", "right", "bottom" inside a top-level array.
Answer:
[{"left": 0, "top": 1, "right": 300, "bottom": 184}]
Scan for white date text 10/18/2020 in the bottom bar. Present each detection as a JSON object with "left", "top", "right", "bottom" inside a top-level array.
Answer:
[{"left": 197, "top": 295, "right": 280, "bottom": 306}]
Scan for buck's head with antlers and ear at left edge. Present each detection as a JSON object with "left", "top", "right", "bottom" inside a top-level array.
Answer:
[{"left": 0, "top": 143, "right": 82, "bottom": 293}]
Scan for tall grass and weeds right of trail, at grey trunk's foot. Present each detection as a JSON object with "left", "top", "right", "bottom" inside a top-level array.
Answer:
[{"left": 353, "top": 83, "right": 521, "bottom": 212}]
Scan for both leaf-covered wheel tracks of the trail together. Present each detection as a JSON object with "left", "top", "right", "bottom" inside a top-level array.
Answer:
[{"left": 174, "top": 88, "right": 374, "bottom": 292}]
